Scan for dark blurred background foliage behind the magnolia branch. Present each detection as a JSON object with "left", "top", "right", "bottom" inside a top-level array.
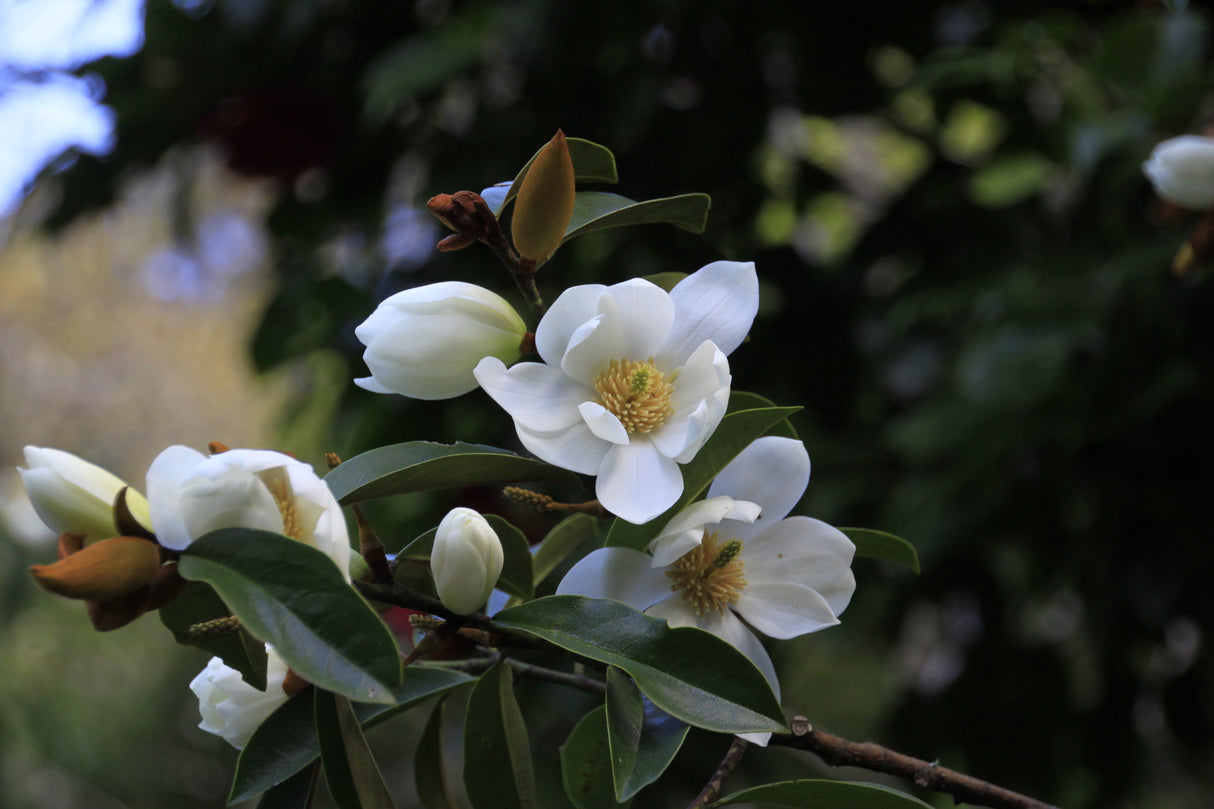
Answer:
[{"left": 0, "top": 0, "right": 1214, "bottom": 809}]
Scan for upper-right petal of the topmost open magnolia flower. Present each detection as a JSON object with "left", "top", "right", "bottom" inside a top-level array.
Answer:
[{"left": 660, "top": 261, "right": 759, "bottom": 366}]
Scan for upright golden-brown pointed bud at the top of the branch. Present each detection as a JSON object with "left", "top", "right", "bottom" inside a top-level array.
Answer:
[{"left": 510, "top": 130, "right": 574, "bottom": 265}]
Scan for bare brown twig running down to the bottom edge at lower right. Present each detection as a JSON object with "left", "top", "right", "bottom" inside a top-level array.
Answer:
[{"left": 771, "top": 717, "right": 1057, "bottom": 809}]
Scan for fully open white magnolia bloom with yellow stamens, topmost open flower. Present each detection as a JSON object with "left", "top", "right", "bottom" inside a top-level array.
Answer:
[{"left": 476, "top": 261, "right": 759, "bottom": 524}]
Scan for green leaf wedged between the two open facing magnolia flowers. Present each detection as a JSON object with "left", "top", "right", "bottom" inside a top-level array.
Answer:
[{"left": 603, "top": 407, "right": 801, "bottom": 550}]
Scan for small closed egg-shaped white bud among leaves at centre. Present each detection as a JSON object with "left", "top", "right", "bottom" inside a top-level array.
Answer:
[{"left": 430, "top": 508, "right": 505, "bottom": 615}]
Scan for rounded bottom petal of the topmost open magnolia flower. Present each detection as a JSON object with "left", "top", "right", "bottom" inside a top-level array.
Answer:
[{"left": 595, "top": 436, "right": 682, "bottom": 525}]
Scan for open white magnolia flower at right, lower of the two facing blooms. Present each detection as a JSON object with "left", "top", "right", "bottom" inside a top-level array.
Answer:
[{"left": 556, "top": 436, "right": 856, "bottom": 743}]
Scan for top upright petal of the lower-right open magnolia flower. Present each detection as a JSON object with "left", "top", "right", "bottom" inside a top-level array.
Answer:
[{"left": 708, "top": 436, "right": 810, "bottom": 529}]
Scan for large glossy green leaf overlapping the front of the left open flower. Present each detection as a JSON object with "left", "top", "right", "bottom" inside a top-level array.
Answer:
[{"left": 178, "top": 528, "right": 401, "bottom": 702}]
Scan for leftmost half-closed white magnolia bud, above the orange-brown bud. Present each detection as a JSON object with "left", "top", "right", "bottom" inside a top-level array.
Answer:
[{"left": 17, "top": 447, "right": 151, "bottom": 541}]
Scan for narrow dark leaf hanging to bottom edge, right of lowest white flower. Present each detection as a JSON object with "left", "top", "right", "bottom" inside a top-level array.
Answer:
[{"left": 313, "top": 689, "right": 396, "bottom": 809}]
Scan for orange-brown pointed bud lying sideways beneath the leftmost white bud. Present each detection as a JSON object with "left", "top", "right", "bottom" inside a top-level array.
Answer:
[{"left": 29, "top": 537, "right": 160, "bottom": 601}]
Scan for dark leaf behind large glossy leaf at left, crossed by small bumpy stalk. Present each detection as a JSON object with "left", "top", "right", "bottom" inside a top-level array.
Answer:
[{"left": 159, "top": 582, "right": 266, "bottom": 691}]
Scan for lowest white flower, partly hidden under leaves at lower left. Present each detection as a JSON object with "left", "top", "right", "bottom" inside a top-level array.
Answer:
[{"left": 189, "top": 644, "right": 290, "bottom": 749}]
